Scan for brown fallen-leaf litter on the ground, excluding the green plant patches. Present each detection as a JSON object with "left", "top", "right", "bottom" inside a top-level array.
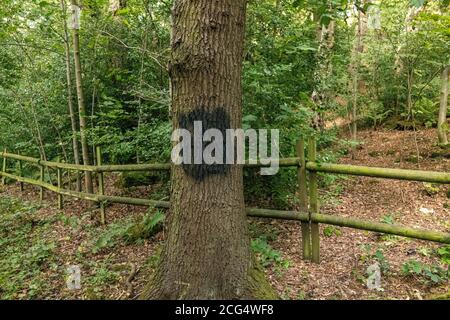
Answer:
[{"left": 0, "top": 130, "right": 450, "bottom": 299}]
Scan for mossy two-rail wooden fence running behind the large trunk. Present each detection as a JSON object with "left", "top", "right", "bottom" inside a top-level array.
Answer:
[{"left": 0, "top": 138, "right": 450, "bottom": 263}]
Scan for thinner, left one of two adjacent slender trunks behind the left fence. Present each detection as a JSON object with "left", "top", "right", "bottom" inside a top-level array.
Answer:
[{"left": 61, "top": 0, "right": 81, "bottom": 191}]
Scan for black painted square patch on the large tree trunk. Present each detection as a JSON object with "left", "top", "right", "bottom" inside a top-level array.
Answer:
[{"left": 178, "top": 107, "right": 230, "bottom": 181}]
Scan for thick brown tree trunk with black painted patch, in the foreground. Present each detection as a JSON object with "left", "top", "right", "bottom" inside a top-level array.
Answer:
[{"left": 141, "top": 0, "right": 274, "bottom": 299}]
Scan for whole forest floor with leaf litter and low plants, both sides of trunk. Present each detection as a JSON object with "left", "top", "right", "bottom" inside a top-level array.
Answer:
[{"left": 0, "top": 130, "right": 450, "bottom": 299}]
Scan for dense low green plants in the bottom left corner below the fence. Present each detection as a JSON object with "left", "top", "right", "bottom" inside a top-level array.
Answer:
[{"left": 0, "top": 197, "right": 58, "bottom": 299}]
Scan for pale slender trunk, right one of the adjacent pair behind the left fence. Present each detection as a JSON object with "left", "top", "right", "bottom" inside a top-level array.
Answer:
[{"left": 71, "top": 0, "right": 94, "bottom": 193}]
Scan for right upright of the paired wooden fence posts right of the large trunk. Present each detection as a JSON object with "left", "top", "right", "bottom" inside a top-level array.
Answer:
[{"left": 308, "top": 137, "right": 320, "bottom": 263}]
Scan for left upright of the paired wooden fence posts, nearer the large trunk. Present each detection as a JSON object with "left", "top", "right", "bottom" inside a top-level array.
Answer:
[{"left": 296, "top": 139, "right": 311, "bottom": 260}]
